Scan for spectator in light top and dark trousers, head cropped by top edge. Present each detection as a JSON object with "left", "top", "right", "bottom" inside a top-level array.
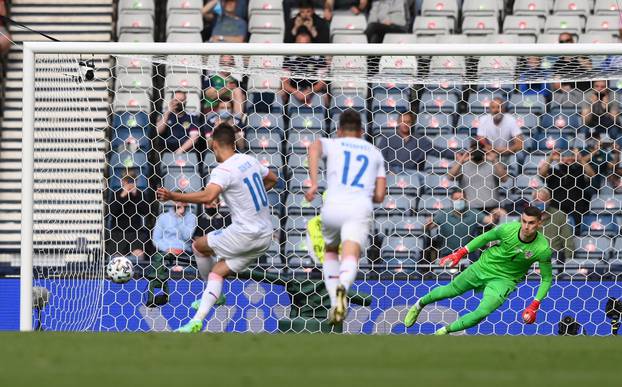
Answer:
[{"left": 365, "top": 0, "right": 410, "bottom": 43}]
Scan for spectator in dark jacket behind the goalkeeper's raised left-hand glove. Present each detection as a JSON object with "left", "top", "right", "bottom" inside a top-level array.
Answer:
[{"left": 425, "top": 189, "right": 505, "bottom": 262}]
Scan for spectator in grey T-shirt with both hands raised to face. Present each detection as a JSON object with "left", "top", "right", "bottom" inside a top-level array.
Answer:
[{"left": 448, "top": 142, "right": 508, "bottom": 211}]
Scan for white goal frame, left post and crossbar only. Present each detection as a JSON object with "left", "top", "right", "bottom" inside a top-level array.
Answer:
[{"left": 20, "top": 42, "right": 622, "bottom": 331}]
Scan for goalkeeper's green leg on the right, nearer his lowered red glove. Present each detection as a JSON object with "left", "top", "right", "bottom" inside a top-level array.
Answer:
[{"left": 435, "top": 281, "right": 514, "bottom": 335}]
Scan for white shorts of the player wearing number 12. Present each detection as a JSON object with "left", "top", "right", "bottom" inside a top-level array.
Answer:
[{"left": 322, "top": 205, "right": 372, "bottom": 250}]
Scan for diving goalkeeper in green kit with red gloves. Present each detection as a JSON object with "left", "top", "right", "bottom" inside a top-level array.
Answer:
[{"left": 404, "top": 207, "right": 553, "bottom": 335}]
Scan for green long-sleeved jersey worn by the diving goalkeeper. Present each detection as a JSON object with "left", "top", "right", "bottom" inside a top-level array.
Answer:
[{"left": 466, "top": 222, "right": 553, "bottom": 300}]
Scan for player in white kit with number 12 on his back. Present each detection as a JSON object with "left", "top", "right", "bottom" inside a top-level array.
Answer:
[{"left": 305, "top": 110, "right": 387, "bottom": 324}]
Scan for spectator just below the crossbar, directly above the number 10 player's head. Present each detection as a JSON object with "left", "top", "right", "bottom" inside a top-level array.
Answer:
[{"left": 202, "top": 55, "right": 246, "bottom": 114}]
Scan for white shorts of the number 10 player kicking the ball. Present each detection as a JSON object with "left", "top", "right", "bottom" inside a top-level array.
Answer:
[{"left": 207, "top": 225, "right": 272, "bottom": 273}]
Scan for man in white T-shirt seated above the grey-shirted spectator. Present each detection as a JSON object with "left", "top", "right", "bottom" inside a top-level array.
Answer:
[{"left": 477, "top": 97, "right": 524, "bottom": 156}]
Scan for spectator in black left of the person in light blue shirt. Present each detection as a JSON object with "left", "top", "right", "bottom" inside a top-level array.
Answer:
[{"left": 107, "top": 174, "right": 153, "bottom": 263}]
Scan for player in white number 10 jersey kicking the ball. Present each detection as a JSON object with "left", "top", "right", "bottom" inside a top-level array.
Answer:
[{"left": 157, "top": 123, "right": 277, "bottom": 332}]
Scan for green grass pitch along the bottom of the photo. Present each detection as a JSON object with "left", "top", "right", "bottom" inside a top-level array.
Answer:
[{"left": 0, "top": 332, "right": 622, "bottom": 387}]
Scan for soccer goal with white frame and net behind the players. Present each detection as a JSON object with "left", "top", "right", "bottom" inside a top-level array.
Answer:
[{"left": 20, "top": 41, "right": 622, "bottom": 335}]
